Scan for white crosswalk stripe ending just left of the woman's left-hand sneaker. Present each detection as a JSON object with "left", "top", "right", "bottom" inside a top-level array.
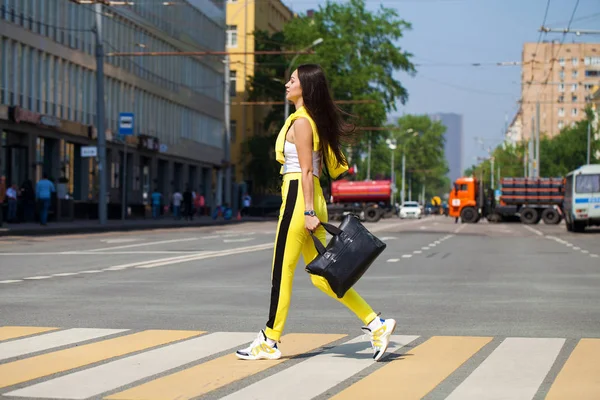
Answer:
[{"left": 7, "top": 332, "right": 256, "bottom": 399}]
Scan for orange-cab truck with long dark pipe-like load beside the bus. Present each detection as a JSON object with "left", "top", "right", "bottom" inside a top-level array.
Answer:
[{"left": 448, "top": 177, "right": 564, "bottom": 225}]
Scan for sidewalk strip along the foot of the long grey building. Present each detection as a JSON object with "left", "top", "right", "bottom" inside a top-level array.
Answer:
[{"left": 0, "top": 216, "right": 274, "bottom": 237}]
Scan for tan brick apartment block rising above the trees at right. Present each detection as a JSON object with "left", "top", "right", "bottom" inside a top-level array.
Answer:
[{"left": 517, "top": 42, "right": 600, "bottom": 140}]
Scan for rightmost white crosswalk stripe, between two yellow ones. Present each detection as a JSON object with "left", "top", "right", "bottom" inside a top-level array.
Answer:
[{"left": 446, "top": 338, "right": 565, "bottom": 400}]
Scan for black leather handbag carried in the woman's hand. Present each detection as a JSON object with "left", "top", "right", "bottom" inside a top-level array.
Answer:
[{"left": 305, "top": 214, "right": 386, "bottom": 299}]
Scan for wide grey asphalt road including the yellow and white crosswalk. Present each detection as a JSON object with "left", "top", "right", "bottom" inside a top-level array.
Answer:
[{"left": 0, "top": 217, "right": 600, "bottom": 399}]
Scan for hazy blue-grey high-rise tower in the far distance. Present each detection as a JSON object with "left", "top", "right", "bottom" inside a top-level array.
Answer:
[{"left": 431, "top": 113, "right": 463, "bottom": 182}]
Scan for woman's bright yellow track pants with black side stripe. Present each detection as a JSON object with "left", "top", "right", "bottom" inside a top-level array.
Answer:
[{"left": 265, "top": 173, "right": 377, "bottom": 340}]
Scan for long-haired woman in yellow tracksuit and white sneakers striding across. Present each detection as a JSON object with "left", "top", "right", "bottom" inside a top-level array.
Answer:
[{"left": 236, "top": 64, "right": 396, "bottom": 361}]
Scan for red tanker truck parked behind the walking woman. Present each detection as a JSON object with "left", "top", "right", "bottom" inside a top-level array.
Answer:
[{"left": 327, "top": 180, "right": 398, "bottom": 222}]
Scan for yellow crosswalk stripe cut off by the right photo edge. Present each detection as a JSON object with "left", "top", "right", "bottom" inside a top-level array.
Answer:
[{"left": 546, "top": 339, "right": 600, "bottom": 400}]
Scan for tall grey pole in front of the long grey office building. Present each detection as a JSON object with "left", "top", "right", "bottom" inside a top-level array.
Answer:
[{"left": 94, "top": 3, "right": 107, "bottom": 225}]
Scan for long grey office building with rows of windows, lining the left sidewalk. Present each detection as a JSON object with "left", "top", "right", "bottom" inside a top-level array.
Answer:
[{"left": 0, "top": 0, "right": 225, "bottom": 218}]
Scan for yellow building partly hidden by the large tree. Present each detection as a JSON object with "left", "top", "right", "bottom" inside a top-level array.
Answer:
[{"left": 227, "top": 0, "right": 294, "bottom": 187}]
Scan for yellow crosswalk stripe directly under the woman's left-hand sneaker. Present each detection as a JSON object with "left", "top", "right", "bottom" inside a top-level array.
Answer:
[{"left": 106, "top": 334, "right": 346, "bottom": 400}]
